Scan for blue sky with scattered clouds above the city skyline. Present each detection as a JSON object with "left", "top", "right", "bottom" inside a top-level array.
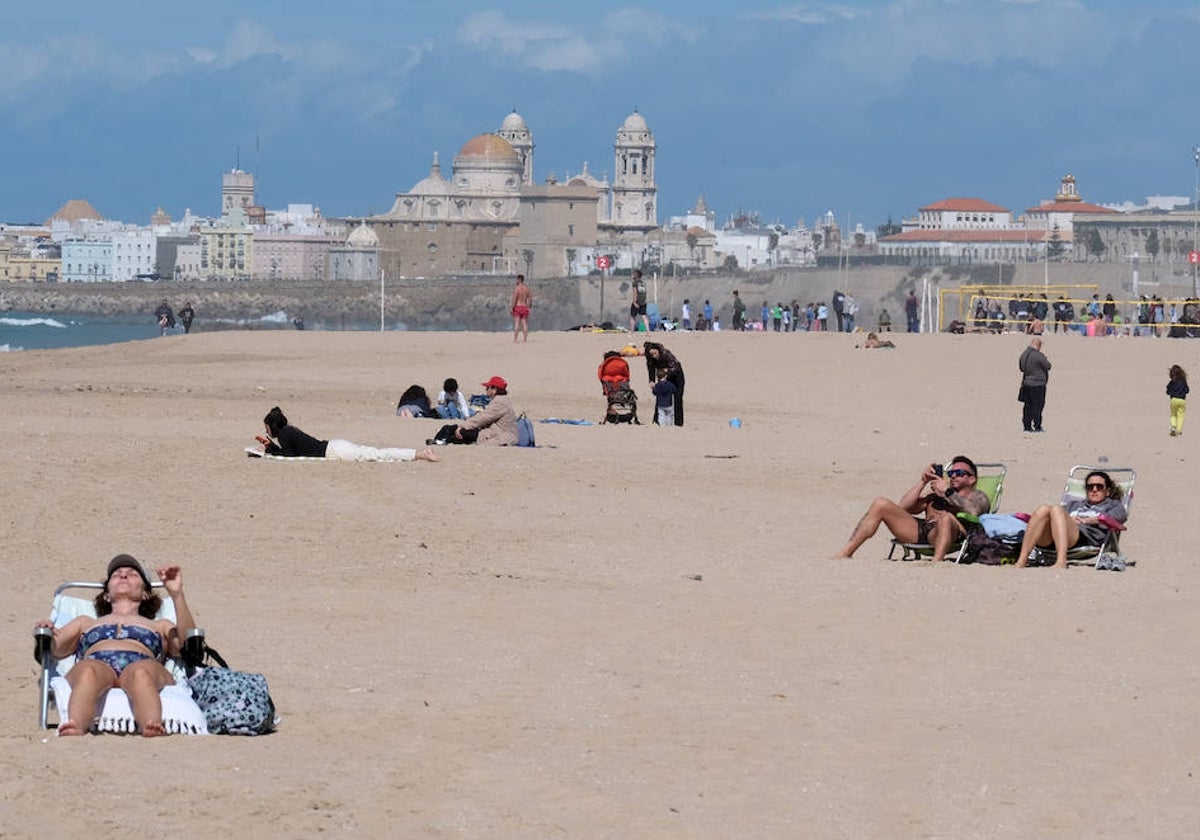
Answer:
[{"left": 0, "top": 0, "right": 1200, "bottom": 228}]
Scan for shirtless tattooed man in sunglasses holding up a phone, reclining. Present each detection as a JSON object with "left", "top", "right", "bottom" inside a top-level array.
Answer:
[{"left": 838, "top": 455, "right": 991, "bottom": 560}]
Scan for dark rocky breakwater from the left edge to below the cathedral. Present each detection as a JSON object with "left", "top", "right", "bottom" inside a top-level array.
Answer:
[{"left": 0, "top": 276, "right": 584, "bottom": 330}]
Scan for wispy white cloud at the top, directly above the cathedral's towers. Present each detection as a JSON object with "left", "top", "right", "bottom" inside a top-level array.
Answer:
[{"left": 457, "top": 8, "right": 700, "bottom": 73}]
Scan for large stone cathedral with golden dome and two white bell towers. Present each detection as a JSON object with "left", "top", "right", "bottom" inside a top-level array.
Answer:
[{"left": 365, "top": 110, "right": 658, "bottom": 277}]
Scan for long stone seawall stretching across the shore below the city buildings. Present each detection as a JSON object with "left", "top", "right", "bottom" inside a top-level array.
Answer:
[{"left": 0, "top": 263, "right": 1192, "bottom": 330}]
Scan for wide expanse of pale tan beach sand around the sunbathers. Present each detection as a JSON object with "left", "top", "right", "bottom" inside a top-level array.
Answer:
[{"left": 0, "top": 323, "right": 1200, "bottom": 839}]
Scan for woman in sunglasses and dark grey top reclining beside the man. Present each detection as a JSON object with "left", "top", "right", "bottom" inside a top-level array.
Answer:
[{"left": 1016, "top": 469, "right": 1126, "bottom": 569}]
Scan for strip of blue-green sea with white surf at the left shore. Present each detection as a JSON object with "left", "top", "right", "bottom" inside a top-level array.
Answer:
[{"left": 0, "top": 311, "right": 406, "bottom": 353}]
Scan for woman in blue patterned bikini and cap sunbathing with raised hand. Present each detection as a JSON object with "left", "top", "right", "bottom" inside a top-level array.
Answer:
[{"left": 37, "top": 554, "right": 196, "bottom": 737}]
